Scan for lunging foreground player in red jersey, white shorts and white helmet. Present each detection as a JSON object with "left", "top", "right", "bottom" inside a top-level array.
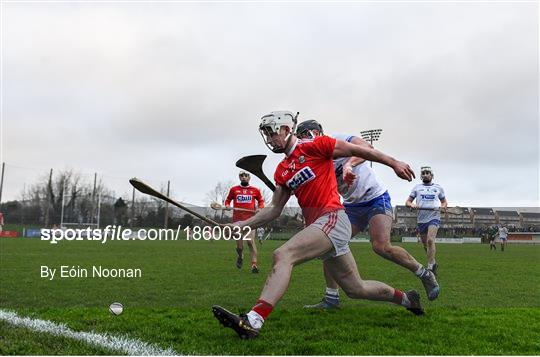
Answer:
[{"left": 212, "top": 111, "right": 423, "bottom": 338}]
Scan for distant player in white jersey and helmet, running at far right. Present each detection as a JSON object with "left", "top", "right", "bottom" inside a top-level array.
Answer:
[{"left": 405, "top": 166, "right": 448, "bottom": 275}]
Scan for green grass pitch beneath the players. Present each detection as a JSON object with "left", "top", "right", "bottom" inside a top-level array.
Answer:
[{"left": 0, "top": 238, "right": 540, "bottom": 355}]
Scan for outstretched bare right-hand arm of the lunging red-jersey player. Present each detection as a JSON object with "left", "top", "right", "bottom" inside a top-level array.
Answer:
[{"left": 333, "top": 140, "right": 416, "bottom": 181}]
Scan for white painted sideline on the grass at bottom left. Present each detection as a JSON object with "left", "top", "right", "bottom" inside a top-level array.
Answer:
[{"left": 0, "top": 309, "right": 177, "bottom": 356}]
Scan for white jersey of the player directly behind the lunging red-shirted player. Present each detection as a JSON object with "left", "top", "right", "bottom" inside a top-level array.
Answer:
[{"left": 330, "top": 134, "right": 386, "bottom": 204}]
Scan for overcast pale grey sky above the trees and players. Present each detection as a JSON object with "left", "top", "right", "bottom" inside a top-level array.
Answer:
[{"left": 1, "top": 2, "right": 539, "bottom": 206}]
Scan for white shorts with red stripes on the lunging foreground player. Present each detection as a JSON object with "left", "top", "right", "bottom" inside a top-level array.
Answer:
[{"left": 310, "top": 209, "right": 352, "bottom": 260}]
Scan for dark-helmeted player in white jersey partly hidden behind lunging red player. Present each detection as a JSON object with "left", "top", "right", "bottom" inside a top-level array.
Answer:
[{"left": 296, "top": 120, "right": 439, "bottom": 309}]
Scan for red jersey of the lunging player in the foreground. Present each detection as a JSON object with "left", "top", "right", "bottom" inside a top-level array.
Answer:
[{"left": 274, "top": 136, "right": 343, "bottom": 226}]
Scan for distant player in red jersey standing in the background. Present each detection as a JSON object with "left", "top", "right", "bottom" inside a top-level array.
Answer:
[{"left": 225, "top": 171, "right": 264, "bottom": 273}]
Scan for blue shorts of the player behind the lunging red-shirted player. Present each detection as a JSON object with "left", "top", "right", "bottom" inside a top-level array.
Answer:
[{"left": 343, "top": 191, "right": 392, "bottom": 231}]
